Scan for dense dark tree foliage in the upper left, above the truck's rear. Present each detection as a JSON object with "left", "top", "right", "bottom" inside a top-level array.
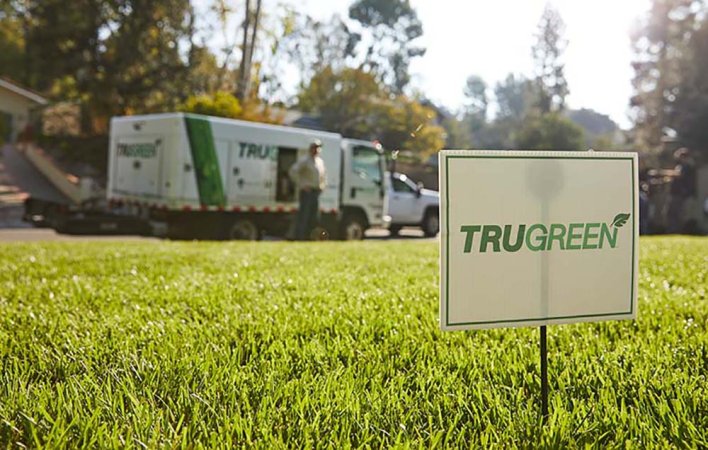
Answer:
[{"left": 0, "top": 0, "right": 203, "bottom": 135}]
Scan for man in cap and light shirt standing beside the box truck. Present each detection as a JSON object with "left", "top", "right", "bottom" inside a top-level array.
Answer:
[{"left": 289, "top": 139, "right": 327, "bottom": 241}]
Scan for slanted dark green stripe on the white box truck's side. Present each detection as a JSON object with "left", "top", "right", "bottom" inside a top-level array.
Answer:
[{"left": 184, "top": 117, "right": 226, "bottom": 206}]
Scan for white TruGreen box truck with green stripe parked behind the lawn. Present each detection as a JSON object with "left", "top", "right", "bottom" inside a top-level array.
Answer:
[{"left": 107, "top": 113, "right": 389, "bottom": 240}]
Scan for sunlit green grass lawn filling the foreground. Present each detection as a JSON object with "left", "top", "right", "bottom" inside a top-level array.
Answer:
[{"left": 0, "top": 238, "right": 708, "bottom": 449}]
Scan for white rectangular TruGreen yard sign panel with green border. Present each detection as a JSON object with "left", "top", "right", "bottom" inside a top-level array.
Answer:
[{"left": 440, "top": 150, "right": 639, "bottom": 330}]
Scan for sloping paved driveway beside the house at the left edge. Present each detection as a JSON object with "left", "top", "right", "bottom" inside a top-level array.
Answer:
[{"left": 0, "top": 145, "right": 67, "bottom": 229}]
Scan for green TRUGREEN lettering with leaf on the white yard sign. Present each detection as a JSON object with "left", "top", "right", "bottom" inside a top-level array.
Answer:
[{"left": 460, "top": 213, "right": 630, "bottom": 253}]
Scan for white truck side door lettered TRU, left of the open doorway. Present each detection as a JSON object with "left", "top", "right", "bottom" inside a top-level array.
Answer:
[{"left": 228, "top": 142, "right": 278, "bottom": 206}]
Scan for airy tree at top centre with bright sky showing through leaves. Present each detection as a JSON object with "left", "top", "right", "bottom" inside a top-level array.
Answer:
[{"left": 349, "top": 0, "right": 425, "bottom": 94}]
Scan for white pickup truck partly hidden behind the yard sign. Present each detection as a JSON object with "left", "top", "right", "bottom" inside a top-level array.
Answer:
[{"left": 385, "top": 172, "right": 440, "bottom": 237}]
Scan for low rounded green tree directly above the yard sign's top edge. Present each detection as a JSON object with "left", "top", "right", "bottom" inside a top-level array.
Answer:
[{"left": 515, "top": 113, "right": 583, "bottom": 150}]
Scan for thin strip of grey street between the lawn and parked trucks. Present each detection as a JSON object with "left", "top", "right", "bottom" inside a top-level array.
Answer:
[{"left": 0, "top": 227, "right": 437, "bottom": 242}]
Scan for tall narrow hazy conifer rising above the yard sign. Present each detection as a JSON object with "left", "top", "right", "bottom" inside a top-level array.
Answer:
[{"left": 531, "top": 4, "right": 568, "bottom": 114}]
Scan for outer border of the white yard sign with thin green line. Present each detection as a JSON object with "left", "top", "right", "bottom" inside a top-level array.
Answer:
[{"left": 440, "top": 150, "right": 637, "bottom": 330}]
